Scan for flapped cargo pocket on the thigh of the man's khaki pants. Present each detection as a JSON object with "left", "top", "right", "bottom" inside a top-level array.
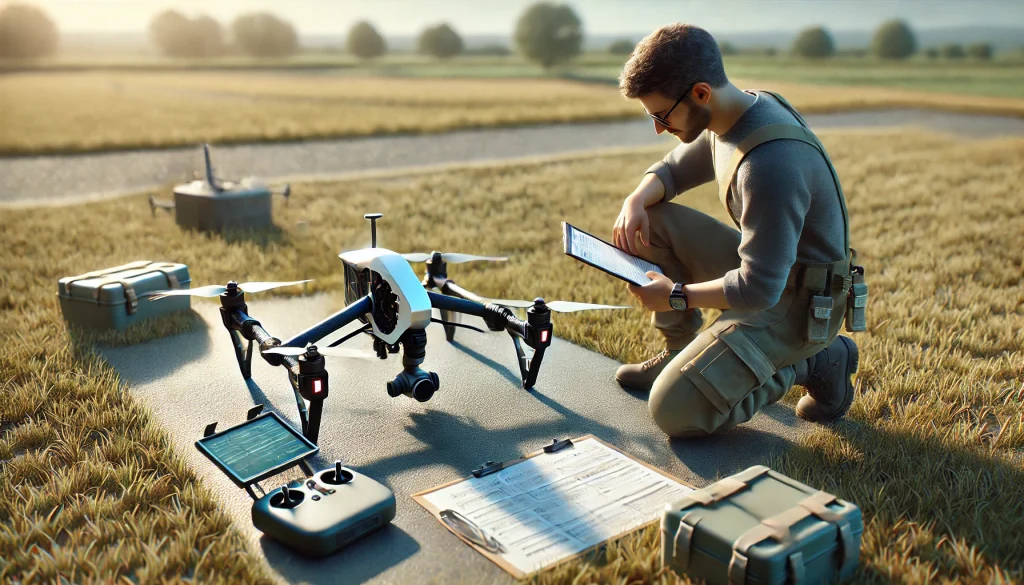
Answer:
[{"left": 681, "top": 325, "right": 775, "bottom": 415}]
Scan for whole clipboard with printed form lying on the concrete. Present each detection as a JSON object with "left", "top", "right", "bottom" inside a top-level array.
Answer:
[{"left": 412, "top": 434, "right": 695, "bottom": 579}]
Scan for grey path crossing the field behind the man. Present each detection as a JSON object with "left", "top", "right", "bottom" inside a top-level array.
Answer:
[{"left": 0, "top": 110, "right": 1024, "bottom": 207}]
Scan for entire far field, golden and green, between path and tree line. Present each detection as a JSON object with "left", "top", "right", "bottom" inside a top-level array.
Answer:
[{"left": 0, "top": 55, "right": 1024, "bottom": 156}]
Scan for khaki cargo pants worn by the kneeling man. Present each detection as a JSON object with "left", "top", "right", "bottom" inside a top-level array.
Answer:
[{"left": 639, "top": 202, "right": 851, "bottom": 436}]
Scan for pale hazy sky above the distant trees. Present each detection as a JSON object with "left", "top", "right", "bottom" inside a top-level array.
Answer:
[{"left": 18, "top": 0, "right": 1024, "bottom": 35}]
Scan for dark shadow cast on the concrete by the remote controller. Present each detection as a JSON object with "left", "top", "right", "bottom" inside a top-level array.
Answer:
[{"left": 259, "top": 524, "right": 420, "bottom": 585}]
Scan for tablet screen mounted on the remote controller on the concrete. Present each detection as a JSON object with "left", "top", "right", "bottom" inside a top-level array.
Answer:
[{"left": 196, "top": 412, "right": 319, "bottom": 488}]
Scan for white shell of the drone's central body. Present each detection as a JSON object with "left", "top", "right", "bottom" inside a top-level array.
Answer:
[{"left": 338, "top": 248, "right": 432, "bottom": 344}]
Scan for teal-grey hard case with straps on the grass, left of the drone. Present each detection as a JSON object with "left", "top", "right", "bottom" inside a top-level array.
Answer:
[{"left": 57, "top": 260, "right": 191, "bottom": 331}]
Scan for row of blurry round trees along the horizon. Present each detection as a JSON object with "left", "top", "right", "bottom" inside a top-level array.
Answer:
[{"left": 0, "top": 2, "right": 1007, "bottom": 68}]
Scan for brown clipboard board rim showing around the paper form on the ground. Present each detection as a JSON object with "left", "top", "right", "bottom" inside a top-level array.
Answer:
[{"left": 412, "top": 434, "right": 696, "bottom": 580}]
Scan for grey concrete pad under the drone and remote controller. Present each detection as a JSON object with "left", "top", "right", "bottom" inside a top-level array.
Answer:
[{"left": 102, "top": 295, "right": 813, "bottom": 583}]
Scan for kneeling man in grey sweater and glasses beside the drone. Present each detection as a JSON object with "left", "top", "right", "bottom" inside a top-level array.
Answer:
[{"left": 613, "top": 24, "right": 866, "bottom": 436}]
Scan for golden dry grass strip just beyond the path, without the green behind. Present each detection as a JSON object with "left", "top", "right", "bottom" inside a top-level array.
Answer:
[{"left": 0, "top": 70, "right": 1024, "bottom": 156}]
